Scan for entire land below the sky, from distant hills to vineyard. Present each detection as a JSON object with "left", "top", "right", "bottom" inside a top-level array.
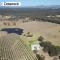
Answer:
[{"left": 0, "top": 0, "right": 60, "bottom": 60}]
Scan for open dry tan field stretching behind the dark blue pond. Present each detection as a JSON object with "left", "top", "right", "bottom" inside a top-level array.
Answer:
[{"left": 0, "top": 21, "right": 60, "bottom": 46}]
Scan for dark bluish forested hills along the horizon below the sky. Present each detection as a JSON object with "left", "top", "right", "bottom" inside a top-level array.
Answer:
[{"left": 0, "top": 5, "right": 60, "bottom": 16}]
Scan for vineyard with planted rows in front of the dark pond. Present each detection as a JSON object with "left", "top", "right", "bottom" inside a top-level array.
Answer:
[{"left": 0, "top": 34, "right": 37, "bottom": 60}]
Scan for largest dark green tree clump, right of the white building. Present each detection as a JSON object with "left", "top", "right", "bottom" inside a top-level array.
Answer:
[{"left": 40, "top": 41, "right": 60, "bottom": 56}]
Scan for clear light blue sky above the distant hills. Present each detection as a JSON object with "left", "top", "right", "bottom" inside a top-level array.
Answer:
[{"left": 0, "top": 0, "right": 60, "bottom": 7}]
